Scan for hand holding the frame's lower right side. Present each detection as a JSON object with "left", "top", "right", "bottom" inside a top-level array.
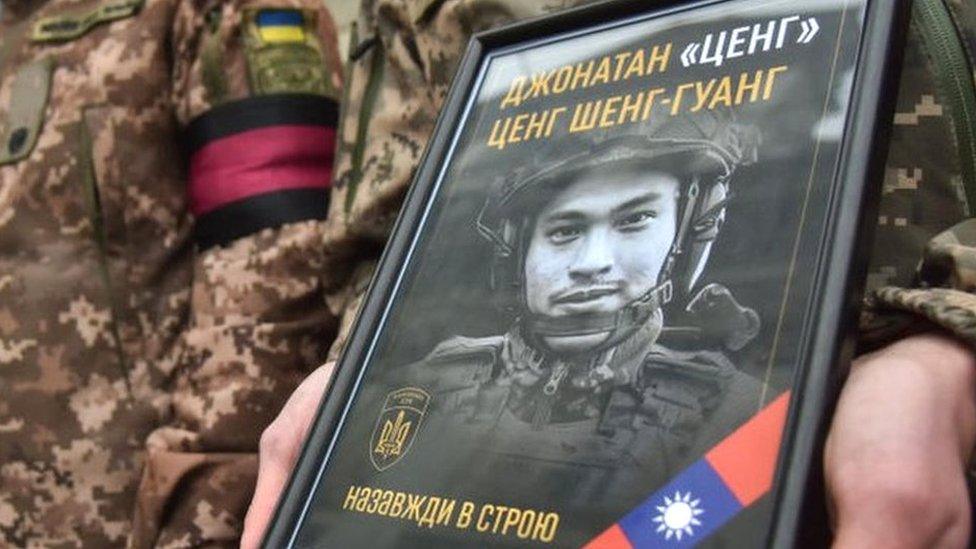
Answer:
[{"left": 824, "top": 333, "right": 976, "bottom": 549}]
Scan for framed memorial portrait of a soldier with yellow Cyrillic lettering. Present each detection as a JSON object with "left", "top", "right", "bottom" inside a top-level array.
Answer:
[{"left": 265, "top": 0, "right": 908, "bottom": 548}]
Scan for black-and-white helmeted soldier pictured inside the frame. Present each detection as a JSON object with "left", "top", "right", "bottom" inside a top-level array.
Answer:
[{"left": 393, "top": 107, "right": 761, "bottom": 484}]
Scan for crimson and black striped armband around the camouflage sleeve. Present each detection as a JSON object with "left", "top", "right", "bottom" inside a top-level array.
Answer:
[{"left": 186, "top": 94, "right": 338, "bottom": 249}]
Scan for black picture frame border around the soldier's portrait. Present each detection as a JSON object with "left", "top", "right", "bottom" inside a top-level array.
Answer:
[{"left": 263, "top": 0, "right": 910, "bottom": 548}]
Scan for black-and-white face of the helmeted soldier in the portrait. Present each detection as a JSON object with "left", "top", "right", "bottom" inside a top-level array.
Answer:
[{"left": 525, "top": 163, "right": 680, "bottom": 352}]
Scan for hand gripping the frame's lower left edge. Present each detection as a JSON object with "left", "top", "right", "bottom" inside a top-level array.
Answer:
[{"left": 241, "top": 362, "right": 335, "bottom": 549}]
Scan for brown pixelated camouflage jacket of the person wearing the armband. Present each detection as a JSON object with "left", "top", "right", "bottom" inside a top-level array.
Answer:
[{"left": 0, "top": 0, "right": 341, "bottom": 547}]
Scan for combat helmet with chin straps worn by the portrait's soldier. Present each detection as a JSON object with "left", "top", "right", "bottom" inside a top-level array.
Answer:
[{"left": 477, "top": 111, "right": 759, "bottom": 348}]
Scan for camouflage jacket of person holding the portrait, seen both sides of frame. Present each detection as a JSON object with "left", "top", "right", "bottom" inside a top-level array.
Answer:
[{"left": 326, "top": 0, "right": 976, "bottom": 356}]
